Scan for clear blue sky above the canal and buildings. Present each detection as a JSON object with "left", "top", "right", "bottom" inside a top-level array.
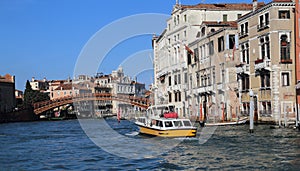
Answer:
[{"left": 0, "top": 0, "right": 270, "bottom": 90}]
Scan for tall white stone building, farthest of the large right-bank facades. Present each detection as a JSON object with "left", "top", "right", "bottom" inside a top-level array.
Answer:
[{"left": 152, "top": 3, "right": 262, "bottom": 117}]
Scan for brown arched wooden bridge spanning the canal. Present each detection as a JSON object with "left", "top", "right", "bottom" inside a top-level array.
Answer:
[{"left": 33, "top": 93, "right": 150, "bottom": 115}]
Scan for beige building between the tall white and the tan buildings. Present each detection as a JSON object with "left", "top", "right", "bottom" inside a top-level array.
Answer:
[{"left": 186, "top": 21, "right": 239, "bottom": 122}]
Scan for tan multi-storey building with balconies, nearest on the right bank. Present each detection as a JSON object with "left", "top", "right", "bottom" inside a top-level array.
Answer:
[{"left": 237, "top": 0, "right": 296, "bottom": 123}]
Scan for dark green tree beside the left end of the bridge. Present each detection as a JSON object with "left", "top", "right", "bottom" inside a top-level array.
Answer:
[{"left": 24, "top": 80, "right": 50, "bottom": 108}]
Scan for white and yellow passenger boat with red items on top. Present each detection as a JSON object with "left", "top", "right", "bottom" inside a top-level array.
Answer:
[{"left": 135, "top": 104, "right": 197, "bottom": 137}]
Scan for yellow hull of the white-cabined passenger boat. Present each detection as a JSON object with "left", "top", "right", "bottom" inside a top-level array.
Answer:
[{"left": 138, "top": 125, "right": 197, "bottom": 137}]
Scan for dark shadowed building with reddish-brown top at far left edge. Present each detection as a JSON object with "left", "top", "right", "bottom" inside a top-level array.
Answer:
[{"left": 0, "top": 74, "right": 16, "bottom": 113}]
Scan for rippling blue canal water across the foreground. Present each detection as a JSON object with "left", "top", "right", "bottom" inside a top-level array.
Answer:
[{"left": 0, "top": 119, "right": 300, "bottom": 170}]
